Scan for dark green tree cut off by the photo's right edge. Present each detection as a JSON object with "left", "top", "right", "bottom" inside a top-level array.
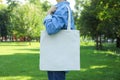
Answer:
[{"left": 99, "top": 0, "right": 120, "bottom": 48}]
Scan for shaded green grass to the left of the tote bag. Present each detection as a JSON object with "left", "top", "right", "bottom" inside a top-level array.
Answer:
[{"left": 0, "top": 53, "right": 47, "bottom": 80}]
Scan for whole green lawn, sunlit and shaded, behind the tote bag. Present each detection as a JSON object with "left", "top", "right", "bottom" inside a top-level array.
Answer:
[{"left": 0, "top": 42, "right": 120, "bottom": 80}]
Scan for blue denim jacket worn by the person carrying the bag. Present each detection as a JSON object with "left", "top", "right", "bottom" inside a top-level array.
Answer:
[{"left": 44, "top": 1, "right": 75, "bottom": 35}]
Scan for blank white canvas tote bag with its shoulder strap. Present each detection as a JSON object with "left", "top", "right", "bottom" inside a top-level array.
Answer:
[{"left": 40, "top": 6, "right": 80, "bottom": 71}]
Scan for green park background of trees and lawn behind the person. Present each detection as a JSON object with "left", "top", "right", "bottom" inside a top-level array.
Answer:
[{"left": 0, "top": 0, "right": 120, "bottom": 80}]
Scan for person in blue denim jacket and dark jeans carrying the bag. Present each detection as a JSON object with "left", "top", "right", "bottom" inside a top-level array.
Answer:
[{"left": 44, "top": 0, "right": 75, "bottom": 80}]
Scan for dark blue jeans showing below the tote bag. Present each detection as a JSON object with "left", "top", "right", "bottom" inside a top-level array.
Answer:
[{"left": 47, "top": 71, "right": 66, "bottom": 80}]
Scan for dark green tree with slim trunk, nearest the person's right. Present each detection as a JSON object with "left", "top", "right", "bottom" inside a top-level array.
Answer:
[{"left": 77, "top": 0, "right": 102, "bottom": 49}]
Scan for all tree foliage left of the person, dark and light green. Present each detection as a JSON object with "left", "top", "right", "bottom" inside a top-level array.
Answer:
[{"left": 0, "top": 0, "right": 49, "bottom": 41}]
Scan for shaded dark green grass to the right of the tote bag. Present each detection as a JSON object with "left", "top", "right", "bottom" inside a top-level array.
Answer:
[{"left": 67, "top": 46, "right": 120, "bottom": 80}]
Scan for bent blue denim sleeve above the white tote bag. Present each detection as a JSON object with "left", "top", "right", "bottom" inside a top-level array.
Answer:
[{"left": 44, "top": 8, "right": 67, "bottom": 35}]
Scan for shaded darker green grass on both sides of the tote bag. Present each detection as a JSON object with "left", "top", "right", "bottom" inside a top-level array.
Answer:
[{"left": 0, "top": 46, "right": 120, "bottom": 80}]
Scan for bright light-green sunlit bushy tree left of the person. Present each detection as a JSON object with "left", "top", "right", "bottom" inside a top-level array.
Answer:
[{"left": 6, "top": 2, "right": 44, "bottom": 41}]
